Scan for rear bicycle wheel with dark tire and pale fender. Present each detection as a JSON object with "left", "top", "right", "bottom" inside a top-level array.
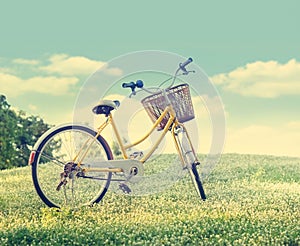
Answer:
[{"left": 32, "top": 125, "right": 113, "bottom": 208}]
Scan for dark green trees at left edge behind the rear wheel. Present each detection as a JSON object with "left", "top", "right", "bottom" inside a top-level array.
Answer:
[{"left": 0, "top": 95, "right": 50, "bottom": 170}]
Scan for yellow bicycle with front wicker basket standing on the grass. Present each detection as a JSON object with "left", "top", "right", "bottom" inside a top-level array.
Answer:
[{"left": 29, "top": 58, "right": 206, "bottom": 208}]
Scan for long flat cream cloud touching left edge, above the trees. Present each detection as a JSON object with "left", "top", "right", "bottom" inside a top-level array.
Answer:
[{"left": 0, "top": 73, "right": 79, "bottom": 97}]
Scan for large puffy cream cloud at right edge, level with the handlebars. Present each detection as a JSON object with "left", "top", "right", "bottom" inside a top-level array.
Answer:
[{"left": 211, "top": 59, "right": 300, "bottom": 98}]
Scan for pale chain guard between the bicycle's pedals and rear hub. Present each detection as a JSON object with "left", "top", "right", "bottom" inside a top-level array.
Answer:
[{"left": 82, "top": 159, "right": 144, "bottom": 183}]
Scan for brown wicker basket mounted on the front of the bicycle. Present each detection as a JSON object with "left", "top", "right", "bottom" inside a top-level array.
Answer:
[{"left": 142, "top": 84, "right": 195, "bottom": 130}]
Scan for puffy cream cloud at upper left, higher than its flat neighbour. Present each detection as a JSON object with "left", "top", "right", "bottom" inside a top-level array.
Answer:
[{"left": 40, "top": 54, "right": 122, "bottom": 76}]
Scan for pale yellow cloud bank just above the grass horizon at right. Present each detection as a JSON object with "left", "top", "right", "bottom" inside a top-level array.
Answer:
[{"left": 225, "top": 122, "right": 300, "bottom": 156}]
